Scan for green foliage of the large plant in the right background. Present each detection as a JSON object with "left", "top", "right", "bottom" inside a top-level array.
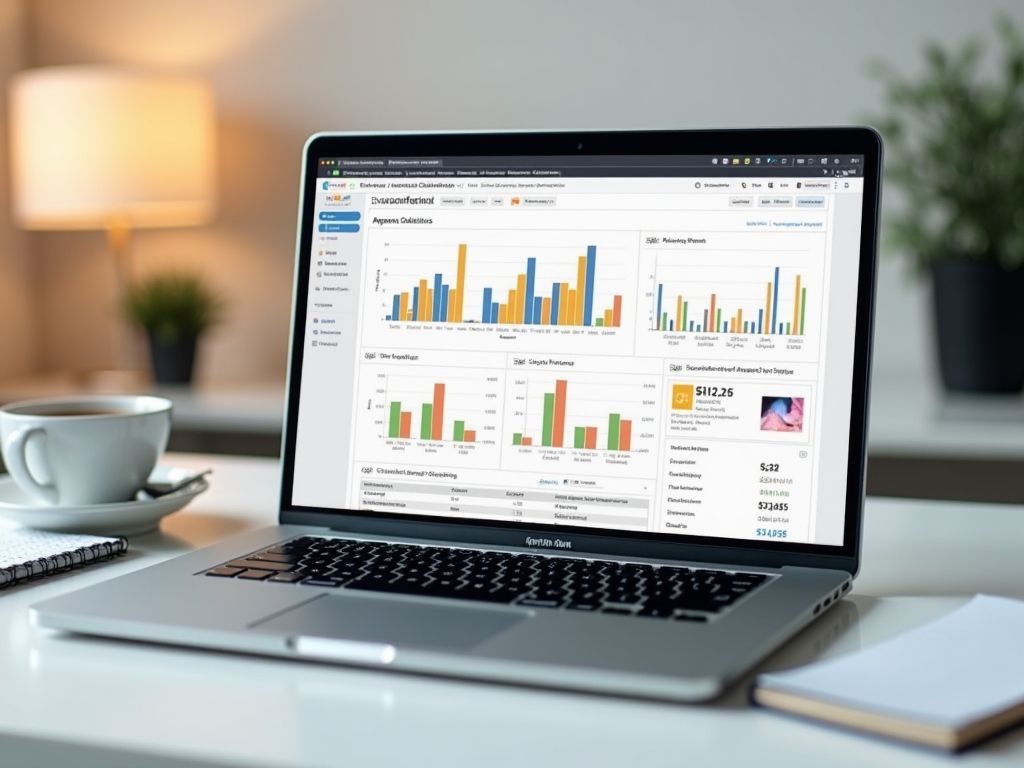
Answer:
[{"left": 871, "top": 17, "right": 1024, "bottom": 270}]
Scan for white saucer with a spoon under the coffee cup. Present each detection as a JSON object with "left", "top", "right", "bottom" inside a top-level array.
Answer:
[{"left": 0, "top": 467, "right": 209, "bottom": 536}]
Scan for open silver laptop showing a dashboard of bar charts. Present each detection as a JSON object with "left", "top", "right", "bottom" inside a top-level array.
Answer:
[{"left": 33, "top": 127, "right": 882, "bottom": 701}]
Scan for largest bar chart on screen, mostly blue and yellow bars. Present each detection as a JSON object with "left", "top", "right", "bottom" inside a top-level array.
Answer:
[{"left": 364, "top": 228, "right": 637, "bottom": 353}]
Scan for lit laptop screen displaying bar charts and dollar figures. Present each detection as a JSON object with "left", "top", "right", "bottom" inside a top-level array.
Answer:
[{"left": 291, "top": 132, "right": 873, "bottom": 561}]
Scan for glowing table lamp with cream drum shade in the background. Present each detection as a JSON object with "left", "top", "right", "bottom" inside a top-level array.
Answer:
[{"left": 9, "top": 65, "right": 215, "bottom": 382}]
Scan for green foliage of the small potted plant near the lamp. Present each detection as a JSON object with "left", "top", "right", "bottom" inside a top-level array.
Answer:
[{"left": 121, "top": 271, "right": 225, "bottom": 343}]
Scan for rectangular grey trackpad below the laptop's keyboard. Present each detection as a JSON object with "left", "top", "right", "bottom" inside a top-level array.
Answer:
[{"left": 252, "top": 595, "right": 529, "bottom": 650}]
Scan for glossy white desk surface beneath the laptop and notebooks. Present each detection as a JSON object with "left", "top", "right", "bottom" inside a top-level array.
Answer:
[{"left": 0, "top": 455, "right": 1024, "bottom": 768}]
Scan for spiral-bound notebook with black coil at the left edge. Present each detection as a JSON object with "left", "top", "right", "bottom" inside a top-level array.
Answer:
[{"left": 0, "top": 528, "right": 128, "bottom": 589}]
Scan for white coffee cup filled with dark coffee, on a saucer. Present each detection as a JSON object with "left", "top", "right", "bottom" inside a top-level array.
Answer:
[{"left": 0, "top": 395, "right": 172, "bottom": 507}]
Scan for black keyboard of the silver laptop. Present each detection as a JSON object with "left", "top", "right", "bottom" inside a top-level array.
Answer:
[{"left": 206, "top": 537, "right": 768, "bottom": 622}]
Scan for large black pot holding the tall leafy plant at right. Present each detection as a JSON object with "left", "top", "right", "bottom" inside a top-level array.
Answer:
[{"left": 932, "top": 261, "right": 1024, "bottom": 392}]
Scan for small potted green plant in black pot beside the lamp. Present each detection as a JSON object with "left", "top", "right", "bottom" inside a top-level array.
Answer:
[{"left": 121, "top": 271, "right": 224, "bottom": 384}]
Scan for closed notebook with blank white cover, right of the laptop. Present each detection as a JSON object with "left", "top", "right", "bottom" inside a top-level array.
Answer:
[{"left": 751, "top": 595, "right": 1024, "bottom": 751}]
